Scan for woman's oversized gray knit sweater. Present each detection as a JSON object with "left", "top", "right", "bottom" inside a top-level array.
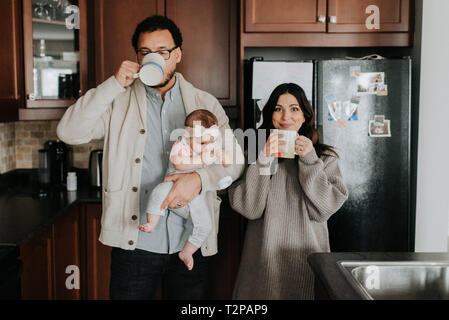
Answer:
[{"left": 229, "top": 150, "right": 348, "bottom": 299}]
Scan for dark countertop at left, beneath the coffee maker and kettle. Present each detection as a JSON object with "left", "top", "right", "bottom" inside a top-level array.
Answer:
[{"left": 0, "top": 169, "right": 101, "bottom": 247}]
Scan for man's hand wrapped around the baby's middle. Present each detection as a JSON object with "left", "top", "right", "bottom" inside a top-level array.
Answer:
[{"left": 161, "top": 172, "right": 202, "bottom": 210}]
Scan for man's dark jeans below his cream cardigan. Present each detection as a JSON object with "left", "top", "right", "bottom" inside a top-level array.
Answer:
[{"left": 109, "top": 248, "right": 209, "bottom": 300}]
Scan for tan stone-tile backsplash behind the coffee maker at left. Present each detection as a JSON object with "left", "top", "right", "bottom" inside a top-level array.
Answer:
[{"left": 0, "top": 121, "right": 103, "bottom": 173}]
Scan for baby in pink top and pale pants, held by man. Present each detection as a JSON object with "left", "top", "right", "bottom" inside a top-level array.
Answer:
[{"left": 139, "top": 109, "right": 232, "bottom": 270}]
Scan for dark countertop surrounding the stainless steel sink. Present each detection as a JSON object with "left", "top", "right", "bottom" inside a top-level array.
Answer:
[{"left": 307, "top": 252, "right": 449, "bottom": 300}]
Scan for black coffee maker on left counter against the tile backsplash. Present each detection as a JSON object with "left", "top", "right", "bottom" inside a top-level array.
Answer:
[{"left": 39, "top": 140, "right": 72, "bottom": 193}]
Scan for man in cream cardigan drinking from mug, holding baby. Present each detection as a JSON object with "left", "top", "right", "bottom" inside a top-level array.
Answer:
[{"left": 57, "top": 16, "right": 244, "bottom": 299}]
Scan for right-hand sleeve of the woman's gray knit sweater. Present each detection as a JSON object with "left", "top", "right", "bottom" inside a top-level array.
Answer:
[{"left": 298, "top": 150, "right": 348, "bottom": 222}]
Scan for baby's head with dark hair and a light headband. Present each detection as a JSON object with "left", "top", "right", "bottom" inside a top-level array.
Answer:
[{"left": 184, "top": 109, "right": 220, "bottom": 153}]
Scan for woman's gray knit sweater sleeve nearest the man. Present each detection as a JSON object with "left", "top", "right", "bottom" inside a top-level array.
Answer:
[{"left": 228, "top": 152, "right": 275, "bottom": 220}]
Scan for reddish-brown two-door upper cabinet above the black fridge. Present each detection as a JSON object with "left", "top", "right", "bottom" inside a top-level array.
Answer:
[{"left": 241, "top": 0, "right": 413, "bottom": 47}]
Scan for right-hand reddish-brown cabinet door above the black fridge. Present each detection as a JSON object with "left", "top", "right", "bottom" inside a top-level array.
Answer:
[{"left": 328, "top": 0, "right": 410, "bottom": 32}]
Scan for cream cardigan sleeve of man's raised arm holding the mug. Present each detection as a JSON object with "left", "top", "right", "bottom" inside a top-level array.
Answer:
[{"left": 56, "top": 76, "right": 125, "bottom": 145}]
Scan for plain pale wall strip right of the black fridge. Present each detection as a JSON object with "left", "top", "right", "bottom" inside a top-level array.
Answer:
[{"left": 415, "top": 0, "right": 449, "bottom": 252}]
